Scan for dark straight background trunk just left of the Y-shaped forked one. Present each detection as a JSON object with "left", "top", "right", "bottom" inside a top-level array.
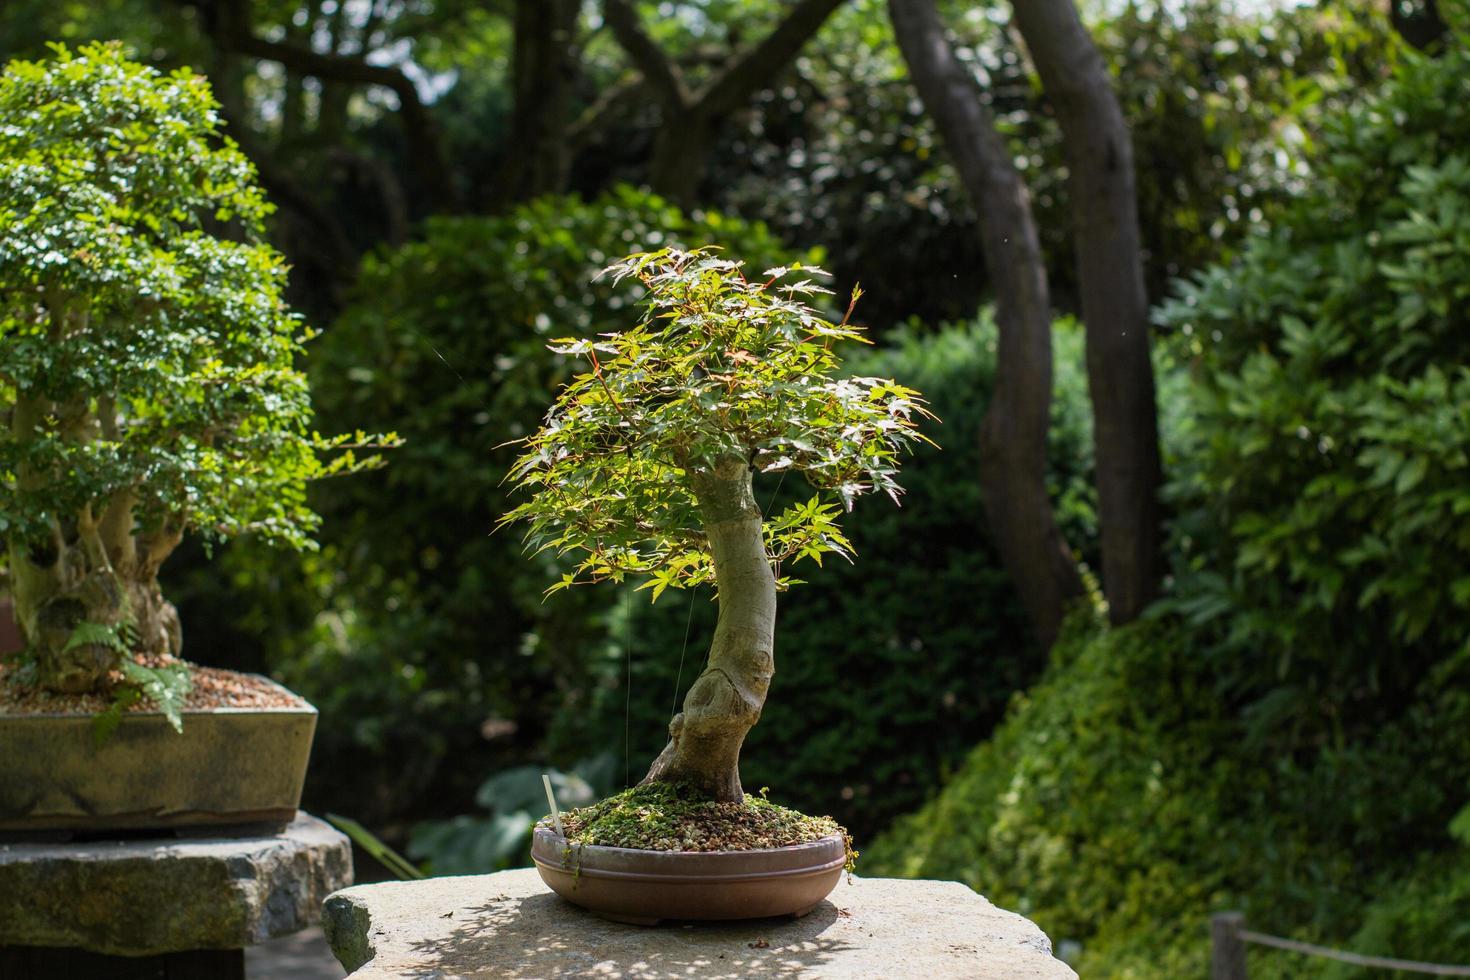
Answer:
[{"left": 495, "top": 0, "right": 581, "bottom": 206}]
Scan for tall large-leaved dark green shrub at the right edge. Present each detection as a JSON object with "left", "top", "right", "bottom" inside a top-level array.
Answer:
[{"left": 1160, "top": 50, "right": 1470, "bottom": 739}]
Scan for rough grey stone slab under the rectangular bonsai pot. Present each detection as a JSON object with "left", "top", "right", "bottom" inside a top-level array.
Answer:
[{"left": 0, "top": 813, "right": 353, "bottom": 956}]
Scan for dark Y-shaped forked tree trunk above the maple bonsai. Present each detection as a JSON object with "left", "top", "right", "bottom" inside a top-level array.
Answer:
[{"left": 603, "top": 0, "right": 844, "bottom": 207}]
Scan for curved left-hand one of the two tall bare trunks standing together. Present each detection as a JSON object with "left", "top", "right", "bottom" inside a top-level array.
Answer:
[{"left": 888, "top": 0, "right": 1082, "bottom": 646}]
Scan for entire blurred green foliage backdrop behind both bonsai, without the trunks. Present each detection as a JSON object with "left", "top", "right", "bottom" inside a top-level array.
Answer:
[{"left": 0, "top": 0, "right": 1470, "bottom": 977}]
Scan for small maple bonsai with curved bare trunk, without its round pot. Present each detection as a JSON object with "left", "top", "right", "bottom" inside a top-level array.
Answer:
[{"left": 501, "top": 248, "right": 928, "bottom": 802}]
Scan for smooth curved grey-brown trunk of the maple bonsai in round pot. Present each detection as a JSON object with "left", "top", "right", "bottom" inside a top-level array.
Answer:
[{"left": 642, "top": 455, "right": 776, "bottom": 802}]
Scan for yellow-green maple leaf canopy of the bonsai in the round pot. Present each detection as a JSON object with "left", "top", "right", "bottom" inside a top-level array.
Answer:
[{"left": 501, "top": 248, "right": 929, "bottom": 599}]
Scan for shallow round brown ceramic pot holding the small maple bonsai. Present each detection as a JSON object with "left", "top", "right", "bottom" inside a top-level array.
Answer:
[{"left": 531, "top": 827, "right": 847, "bottom": 926}]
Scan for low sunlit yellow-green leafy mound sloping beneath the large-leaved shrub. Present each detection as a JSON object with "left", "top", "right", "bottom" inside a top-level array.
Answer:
[{"left": 863, "top": 616, "right": 1470, "bottom": 979}]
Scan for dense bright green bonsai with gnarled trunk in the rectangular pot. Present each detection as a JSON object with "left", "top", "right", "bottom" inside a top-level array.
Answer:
[{"left": 0, "top": 44, "right": 391, "bottom": 724}]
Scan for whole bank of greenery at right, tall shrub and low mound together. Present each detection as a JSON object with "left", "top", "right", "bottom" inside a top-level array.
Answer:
[{"left": 867, "top": 34, "right": 1470, "bottom": 977}]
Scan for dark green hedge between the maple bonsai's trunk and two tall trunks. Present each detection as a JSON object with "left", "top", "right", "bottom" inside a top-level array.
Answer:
[{"left": 547, "top": 314, "right": 1097, "bottom": 846}]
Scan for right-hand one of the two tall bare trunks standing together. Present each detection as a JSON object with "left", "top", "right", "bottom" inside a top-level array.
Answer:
[{"left": 1013, "top": 0, "right": 1163, "bottom": 623}]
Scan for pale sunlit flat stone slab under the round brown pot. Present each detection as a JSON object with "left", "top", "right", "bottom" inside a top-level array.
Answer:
[{"left": 322, "top": 868, "right": 1076, "bottom": 980}]
